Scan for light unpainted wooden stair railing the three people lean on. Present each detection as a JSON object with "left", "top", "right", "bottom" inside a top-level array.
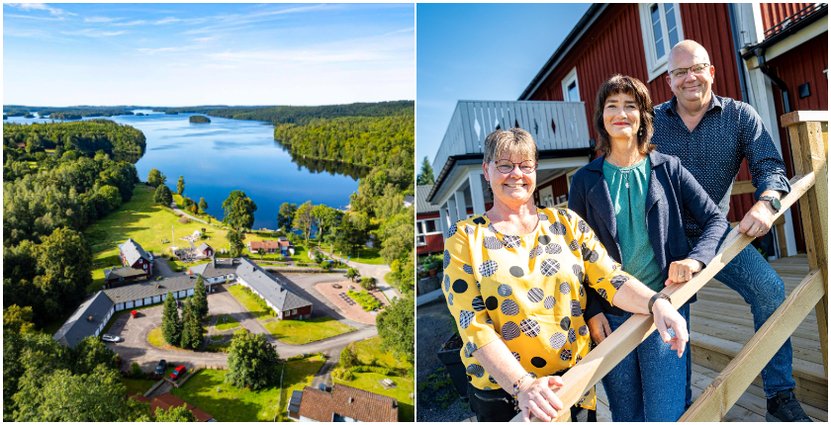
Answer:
[{"left": 513, "top": 111, "right": 828, "bottom": 422}]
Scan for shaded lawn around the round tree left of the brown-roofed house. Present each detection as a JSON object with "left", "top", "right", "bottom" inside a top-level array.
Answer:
[{"left": 171, "top": 356, "right": 323, "bottom": 422}]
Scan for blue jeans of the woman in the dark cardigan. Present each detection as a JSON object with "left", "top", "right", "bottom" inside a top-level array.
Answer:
[{"left": 603, "top": 304, "right": 690, "bottom": 422}]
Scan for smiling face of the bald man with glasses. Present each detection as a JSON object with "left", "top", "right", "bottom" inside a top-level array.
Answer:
[{"left": 666, "top": 43, "right": 716, "bottom": 104}]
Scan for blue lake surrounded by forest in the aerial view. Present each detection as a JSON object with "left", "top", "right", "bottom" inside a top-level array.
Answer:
[{"left": 7, "top": 110, "right": 358, "bottom": 229}]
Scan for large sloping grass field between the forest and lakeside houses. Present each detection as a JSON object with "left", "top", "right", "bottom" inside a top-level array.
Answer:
[{"left": 84, "top": 184, "right": 228, "bottom": 291}]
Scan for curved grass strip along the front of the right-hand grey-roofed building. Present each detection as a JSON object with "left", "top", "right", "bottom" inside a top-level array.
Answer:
[{"left": 228, "top": 285, "right": 355, "bottom": 345}]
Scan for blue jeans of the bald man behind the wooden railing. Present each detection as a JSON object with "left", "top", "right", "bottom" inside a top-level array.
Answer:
[{"left": 686, "top": 240, "right": 796, "bottom": 405}]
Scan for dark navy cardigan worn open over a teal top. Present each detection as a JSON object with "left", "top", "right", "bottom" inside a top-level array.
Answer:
[{"left": 568, "top": 151, "right": 728, "bottom": 320}]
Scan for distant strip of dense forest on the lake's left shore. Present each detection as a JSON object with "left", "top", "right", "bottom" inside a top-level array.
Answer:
[{"left": 3, "top": 119, "right": 146, "bottom": 162}]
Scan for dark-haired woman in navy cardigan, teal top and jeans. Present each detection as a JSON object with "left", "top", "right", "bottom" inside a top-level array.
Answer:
[{"left": 568, "top": 74, "right": 727, "bottom": 422}]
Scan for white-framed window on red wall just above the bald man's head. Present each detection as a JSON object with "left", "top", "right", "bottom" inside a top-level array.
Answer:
[{"left": 640, "top": 3, "right": 684, "bottom": 81}]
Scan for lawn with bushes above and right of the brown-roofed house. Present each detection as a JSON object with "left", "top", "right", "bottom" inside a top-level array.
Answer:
[{"left": 335, "top": 337, "right": 415, "bottom": 421}]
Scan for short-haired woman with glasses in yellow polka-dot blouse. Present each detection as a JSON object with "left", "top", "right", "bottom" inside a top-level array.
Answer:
[{"left": 442, "top": 128, "right": 688, "bottom": 421}]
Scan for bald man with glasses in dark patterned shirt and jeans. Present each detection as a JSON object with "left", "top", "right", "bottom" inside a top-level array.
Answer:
[{"left": 652, "top": 40, "right": 811, "bottom": 422}]
